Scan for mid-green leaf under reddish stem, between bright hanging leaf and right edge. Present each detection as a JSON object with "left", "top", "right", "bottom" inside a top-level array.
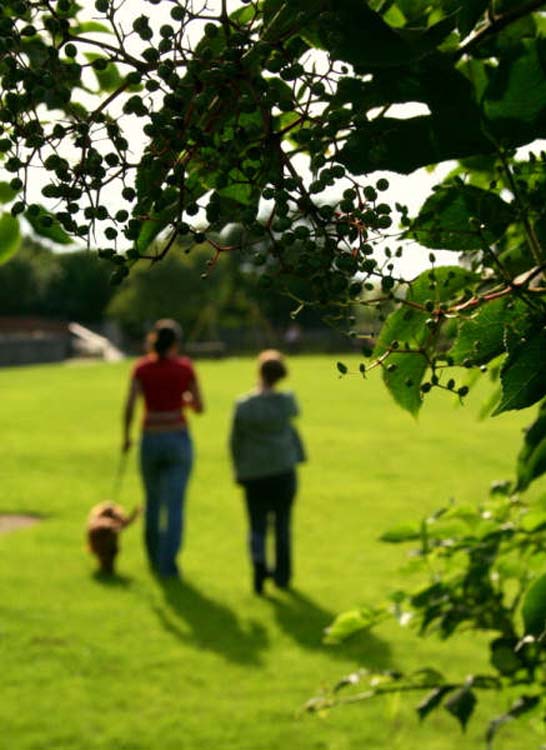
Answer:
[{"left": 449, "top": 298, "right": 530, "bottom": 365}]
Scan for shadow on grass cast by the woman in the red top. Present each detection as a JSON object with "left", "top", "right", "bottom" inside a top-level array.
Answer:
[{"left": 155, "top": 579, "right": 269, "bottom": 666}]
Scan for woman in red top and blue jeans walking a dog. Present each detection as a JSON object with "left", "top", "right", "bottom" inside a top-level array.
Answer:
[{"left": 123, "top": 319, "right": 203, "bottom": 576}]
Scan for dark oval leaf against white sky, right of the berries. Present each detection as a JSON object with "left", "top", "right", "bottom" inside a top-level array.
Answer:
[{"left": 411, "top": 185, "right": 515, "bottom": 252}]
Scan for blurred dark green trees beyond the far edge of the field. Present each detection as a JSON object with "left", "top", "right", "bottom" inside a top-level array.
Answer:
[{"left": 0, "top": 237, "right": 332, "bottom": 341}]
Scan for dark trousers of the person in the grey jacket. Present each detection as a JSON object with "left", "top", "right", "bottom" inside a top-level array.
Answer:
[{"left": 241, "top": 470, "right": 296, "bottom": 586}]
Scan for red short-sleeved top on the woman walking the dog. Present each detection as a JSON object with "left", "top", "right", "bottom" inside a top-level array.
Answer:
[{"left": 133, "top": 354, "right": 195, "bottom": 430}]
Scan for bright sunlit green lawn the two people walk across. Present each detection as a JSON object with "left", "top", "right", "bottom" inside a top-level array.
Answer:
[{"left": 0, "top": 357, "right": 539, "bottom": 750}]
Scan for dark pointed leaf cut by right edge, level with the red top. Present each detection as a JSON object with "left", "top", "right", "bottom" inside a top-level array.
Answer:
[{"left": 493, "top": 330, "right": 546, "bottom": 416}]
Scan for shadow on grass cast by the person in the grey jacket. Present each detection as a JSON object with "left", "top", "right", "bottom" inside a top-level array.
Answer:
[{"left": 267, "top": 589, "right": 392, "bottom": 669}]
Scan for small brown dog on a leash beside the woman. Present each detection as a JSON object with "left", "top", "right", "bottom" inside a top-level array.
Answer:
[{"left": 87, "top": 500, "right": 140, "bottom": 575}]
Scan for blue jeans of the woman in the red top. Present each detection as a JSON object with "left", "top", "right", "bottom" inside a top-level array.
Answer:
[{"left": 140, "top": 430, "right": 193, "bottom": 576}]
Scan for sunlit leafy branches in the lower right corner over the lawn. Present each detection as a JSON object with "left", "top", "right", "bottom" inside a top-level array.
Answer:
[{"left": 306, "top": 487, "right": 546, "bottom": 744}]
